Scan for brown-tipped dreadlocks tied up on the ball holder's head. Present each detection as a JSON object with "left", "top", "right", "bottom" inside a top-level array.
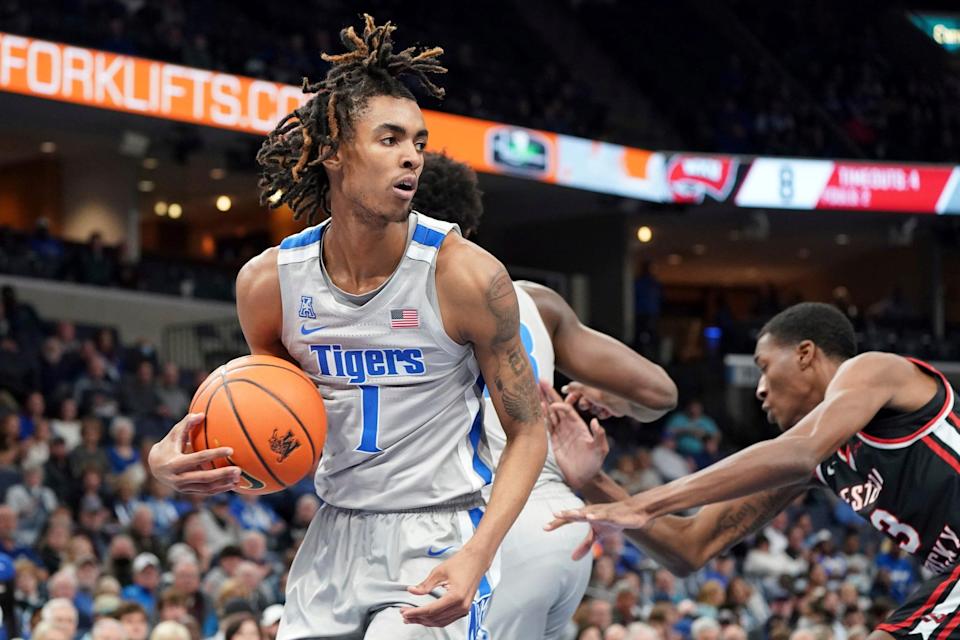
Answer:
[{"left": 257, "top": 14, "right": 447, "bottom": 225}]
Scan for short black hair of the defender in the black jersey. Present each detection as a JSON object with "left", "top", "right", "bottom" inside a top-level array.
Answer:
[{"left": 757, "top": 302, "right": 857, "bottom": 360}]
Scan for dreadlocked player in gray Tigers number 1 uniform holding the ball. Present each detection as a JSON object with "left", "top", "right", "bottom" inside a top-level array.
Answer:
[{"left": 151, "top": 16, "right": 547, "bottom": 640}]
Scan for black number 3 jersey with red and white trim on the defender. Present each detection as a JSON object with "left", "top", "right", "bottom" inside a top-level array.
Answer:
[{"left": 816, "top": 359, "right": 960, "bottom": 573}]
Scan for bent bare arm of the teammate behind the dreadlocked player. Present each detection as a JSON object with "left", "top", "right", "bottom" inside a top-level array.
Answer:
[{"left": 520, "top": 282, "right": 677, "bottom": 422}]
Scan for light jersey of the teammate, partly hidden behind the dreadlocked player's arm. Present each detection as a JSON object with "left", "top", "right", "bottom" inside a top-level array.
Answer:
[{"left": 484, "top": 283, "right": 564, "bottom": 497}]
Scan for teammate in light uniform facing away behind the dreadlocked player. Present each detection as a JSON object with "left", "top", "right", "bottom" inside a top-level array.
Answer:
[{"left": 414, "top": 152, "right": 677, "bottom": 640}]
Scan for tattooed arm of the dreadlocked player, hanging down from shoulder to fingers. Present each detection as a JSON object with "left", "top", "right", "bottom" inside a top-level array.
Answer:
[{"left": 403, "top": 234, "right": 547, "bottom": 626}]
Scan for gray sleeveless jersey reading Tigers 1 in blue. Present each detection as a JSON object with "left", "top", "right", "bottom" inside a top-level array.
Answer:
[{"left": 277, "top": 212, "right": 492, "bottom": 512}]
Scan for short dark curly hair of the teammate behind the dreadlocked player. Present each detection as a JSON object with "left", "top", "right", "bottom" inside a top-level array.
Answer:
[{"left": 413, "top": 151, "right": 483, "bottom": 238}]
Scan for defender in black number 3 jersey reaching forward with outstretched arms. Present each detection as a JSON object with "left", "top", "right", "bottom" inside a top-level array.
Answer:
[{"left": 548, "top": 303, "right": 960, "bottom": 640}]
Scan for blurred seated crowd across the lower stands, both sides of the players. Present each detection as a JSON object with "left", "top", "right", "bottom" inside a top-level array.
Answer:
[{"left": 0, "top": 278, "right": 920, "bottom": 640}]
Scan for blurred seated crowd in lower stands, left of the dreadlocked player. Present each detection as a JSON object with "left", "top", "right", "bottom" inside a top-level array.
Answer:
[{"left": 0, "top": 287, "right": 319, "bottom": 640}]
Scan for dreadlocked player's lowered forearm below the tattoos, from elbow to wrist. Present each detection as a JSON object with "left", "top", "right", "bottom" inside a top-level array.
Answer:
[{"left": 468, "top": 424, "right": 547, "bottom": 559}]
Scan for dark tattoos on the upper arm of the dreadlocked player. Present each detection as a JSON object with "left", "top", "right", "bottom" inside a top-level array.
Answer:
[{"left": 486, "top": 271, "right": 540, "bottom": 422}]
